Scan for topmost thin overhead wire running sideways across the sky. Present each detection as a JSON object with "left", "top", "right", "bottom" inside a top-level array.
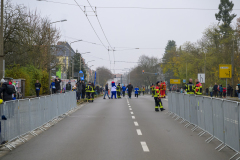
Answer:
[{"left": 38, "top": 0, "right": 240, "bottom": 11}]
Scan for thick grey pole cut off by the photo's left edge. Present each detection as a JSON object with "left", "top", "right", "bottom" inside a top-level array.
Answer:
[{"left": 0, "top": 0, "right": 5, "bottom": 78}]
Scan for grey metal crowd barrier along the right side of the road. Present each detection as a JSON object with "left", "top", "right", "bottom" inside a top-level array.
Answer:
[{"left": 168, "top": 92, "right": 240, "bottom": 160}]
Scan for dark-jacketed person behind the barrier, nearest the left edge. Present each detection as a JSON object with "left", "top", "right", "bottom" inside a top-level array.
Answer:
[{"left": 0, "top": 82, "right": 15, "bottom": 101}]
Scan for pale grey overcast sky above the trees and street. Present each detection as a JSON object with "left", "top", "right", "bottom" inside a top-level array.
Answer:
[{"left": 12, "top": 0, "right": 240, "bottom": 73}]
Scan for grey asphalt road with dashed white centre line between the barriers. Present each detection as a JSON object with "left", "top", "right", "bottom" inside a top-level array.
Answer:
[{"left": 1, "top": 95, "right": 234, "bottom": 160}]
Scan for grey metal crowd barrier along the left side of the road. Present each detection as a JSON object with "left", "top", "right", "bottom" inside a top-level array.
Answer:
[{"left": 0, "top": 92, "right": 77, "bottom": 150}]
